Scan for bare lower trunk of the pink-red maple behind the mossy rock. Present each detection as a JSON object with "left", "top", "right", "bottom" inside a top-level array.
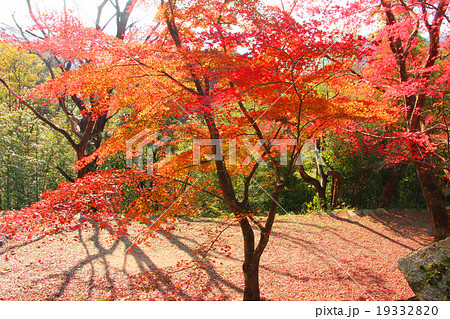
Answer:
[{"left": 416, "top": 163, "right": 450, "bottom": 241}]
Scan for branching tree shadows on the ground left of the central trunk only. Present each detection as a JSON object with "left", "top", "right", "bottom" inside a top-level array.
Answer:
[{"left": 28, "top": 221, "right": 243, "bottom": 300}]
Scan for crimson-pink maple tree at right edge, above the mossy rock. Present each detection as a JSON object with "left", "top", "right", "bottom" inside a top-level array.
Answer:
[{"left": 316, "top": 0, "right": 449, "bottom": 241}]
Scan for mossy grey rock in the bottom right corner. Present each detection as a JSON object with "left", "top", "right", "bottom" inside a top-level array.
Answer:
[{"left": 398, "top": 237, "right": 450, "bottom": 301}]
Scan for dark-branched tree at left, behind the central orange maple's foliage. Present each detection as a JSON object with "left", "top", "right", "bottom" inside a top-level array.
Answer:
[{"left": 0, "top": 0, "right": 134, "bottom": 182}]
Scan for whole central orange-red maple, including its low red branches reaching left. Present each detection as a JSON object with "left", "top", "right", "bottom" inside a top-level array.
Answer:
[{"left": 0, "top": 0, "right": 395, "bottom": 300}]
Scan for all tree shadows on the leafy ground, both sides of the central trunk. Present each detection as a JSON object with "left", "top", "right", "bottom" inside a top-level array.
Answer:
[{"left": 2, "top": 211, "right": 422, "bottom": 300}]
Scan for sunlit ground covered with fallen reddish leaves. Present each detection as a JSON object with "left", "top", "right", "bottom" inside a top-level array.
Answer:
[{"left": 0, "top": 210, "right": 432, "bottom": 300}]
